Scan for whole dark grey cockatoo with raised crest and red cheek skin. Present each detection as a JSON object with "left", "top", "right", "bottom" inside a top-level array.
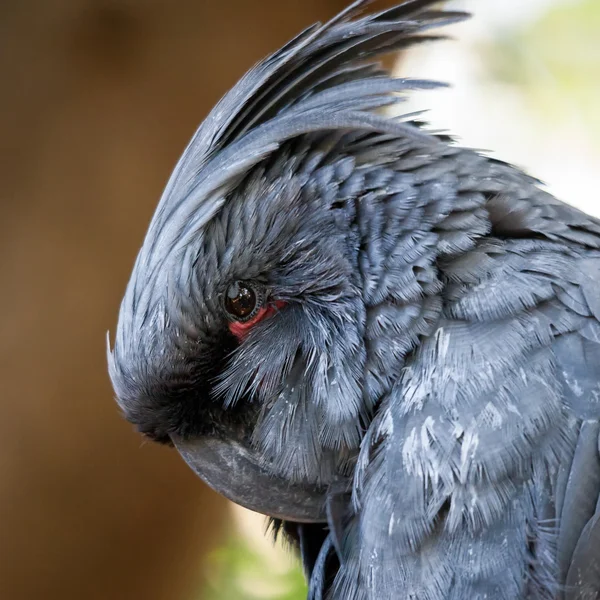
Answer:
[{"left": 109, "top": 0, "right": 600, "bottom": 600}]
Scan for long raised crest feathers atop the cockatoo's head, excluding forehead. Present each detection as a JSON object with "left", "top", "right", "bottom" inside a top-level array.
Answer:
[{"left": 147, "top": 0, "right": 468, "bottom": 258}]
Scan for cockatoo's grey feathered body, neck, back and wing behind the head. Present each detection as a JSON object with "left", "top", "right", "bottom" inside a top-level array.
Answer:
[{"left": 300, "top": 136, "right": 600, "bottom": 600}]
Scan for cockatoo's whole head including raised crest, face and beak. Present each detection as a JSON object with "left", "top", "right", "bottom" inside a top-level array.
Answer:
[{"left": 108, "top": 1, "right": 456, "bottom": 521}]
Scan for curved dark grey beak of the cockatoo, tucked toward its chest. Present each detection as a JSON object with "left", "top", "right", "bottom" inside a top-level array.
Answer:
[{"left": 172, "top": 436, "right": 327, "bottom": 523}]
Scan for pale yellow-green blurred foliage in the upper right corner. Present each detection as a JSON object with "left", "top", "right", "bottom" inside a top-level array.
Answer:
[{"left": 483, "top": 0, "right": 600, "bottom": 139}]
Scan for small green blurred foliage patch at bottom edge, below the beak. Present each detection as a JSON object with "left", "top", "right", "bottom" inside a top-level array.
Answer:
[{"left": 202, "top": 537, "right": 306, "bottom": 600}]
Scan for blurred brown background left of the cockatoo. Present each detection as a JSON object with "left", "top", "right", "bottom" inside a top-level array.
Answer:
[{"left": 0, "top": 0, "right": 384, "bottom": 600}]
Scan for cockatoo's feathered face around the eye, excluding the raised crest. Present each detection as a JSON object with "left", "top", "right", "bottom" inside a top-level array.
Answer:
[{"left": 109, "top": 157, "right": 364, "bottom": 516}]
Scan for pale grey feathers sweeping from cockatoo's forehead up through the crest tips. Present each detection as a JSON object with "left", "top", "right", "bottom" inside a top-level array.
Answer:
[{"left": 109, "top": 0, "right": 467, "bottom": 432}]
